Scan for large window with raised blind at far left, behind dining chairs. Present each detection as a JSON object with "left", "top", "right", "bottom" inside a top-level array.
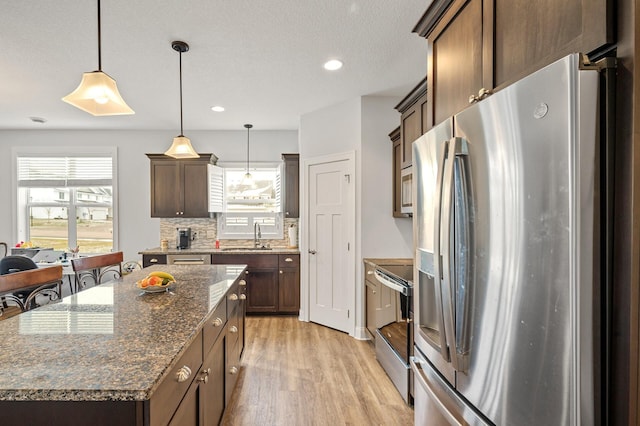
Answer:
[{"left": 16, "top": 153, "right": 115, "bottom": 253}]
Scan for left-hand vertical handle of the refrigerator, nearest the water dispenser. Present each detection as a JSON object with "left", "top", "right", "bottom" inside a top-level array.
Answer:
[{"left": 433, "top": 141, "right": 450, "bottom": 361}]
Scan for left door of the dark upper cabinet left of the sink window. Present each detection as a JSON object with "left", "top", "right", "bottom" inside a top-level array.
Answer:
[{"left": 151, "top": 160, "right": 181, "bottom": 217}]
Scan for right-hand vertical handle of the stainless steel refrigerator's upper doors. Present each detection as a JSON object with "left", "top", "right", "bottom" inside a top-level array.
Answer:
[{"left": 439, "top": 137, "right": 468, "bottom": 371}]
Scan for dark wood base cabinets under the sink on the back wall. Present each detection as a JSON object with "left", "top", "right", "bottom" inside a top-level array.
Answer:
[{"left": 211, "top": 253, "right": 300, "bottom": 314}]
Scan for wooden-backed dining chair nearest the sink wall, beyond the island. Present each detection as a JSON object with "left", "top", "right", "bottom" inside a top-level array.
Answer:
[{"left": 71, "top": 251, "right": 123, "bottom": 291}]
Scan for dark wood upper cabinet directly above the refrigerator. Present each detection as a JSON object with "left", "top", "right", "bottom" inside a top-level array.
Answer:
[{"left": 413, "top": 0, "right": 615, "bottom": 128}]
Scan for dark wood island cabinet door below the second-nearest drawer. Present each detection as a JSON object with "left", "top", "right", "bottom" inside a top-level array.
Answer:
[{"left": 200, "top": 333, "right": 226, "bottom": 425}]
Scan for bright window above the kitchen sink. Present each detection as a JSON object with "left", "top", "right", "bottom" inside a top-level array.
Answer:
[{"left": 217, "top": 166, "right": 283, "bottom": 239}]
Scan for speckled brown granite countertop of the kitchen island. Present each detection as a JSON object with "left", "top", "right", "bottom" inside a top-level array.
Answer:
[{"left": 0, "top": 265, "right": 245, "bottom": 401}]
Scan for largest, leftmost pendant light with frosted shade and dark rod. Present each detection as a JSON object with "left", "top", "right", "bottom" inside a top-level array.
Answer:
[{"left": 62, "top": 0, "right": 135, "bottom": 116}]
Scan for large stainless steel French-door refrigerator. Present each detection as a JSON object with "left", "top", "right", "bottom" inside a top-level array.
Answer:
[{"left": 412, "top": 54, "right": 599, "bottom": 426}]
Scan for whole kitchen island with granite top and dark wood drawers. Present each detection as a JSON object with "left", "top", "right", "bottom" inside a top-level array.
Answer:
[{"left": 0, "top": 265, "right": 246, "bottom": 425}]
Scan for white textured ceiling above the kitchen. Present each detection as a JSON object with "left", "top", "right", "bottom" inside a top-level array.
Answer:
[{"left": 0, "top": 0, "right": 430, "bottom": 133}]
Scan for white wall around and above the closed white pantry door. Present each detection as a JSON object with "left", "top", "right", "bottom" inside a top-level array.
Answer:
[{"left": 299, "top": 96, "right": 412, "bottom": 338}]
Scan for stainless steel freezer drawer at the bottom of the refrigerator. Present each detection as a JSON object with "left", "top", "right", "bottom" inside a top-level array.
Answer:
[{"left": 411, "top": 347, "right": 490, "bottom": 426}]
